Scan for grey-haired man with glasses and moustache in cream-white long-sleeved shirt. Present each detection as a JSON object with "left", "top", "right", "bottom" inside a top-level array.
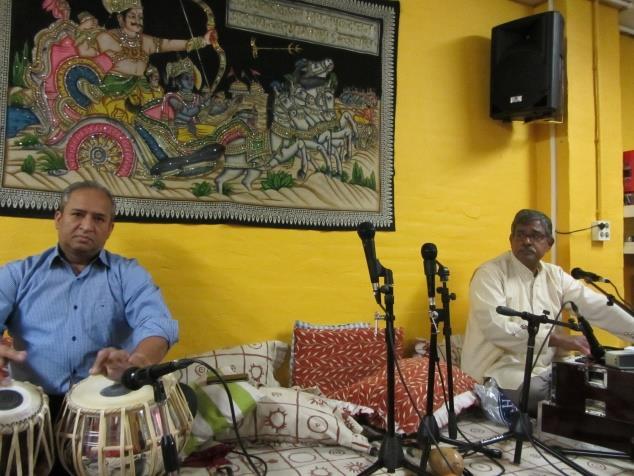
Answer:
[{"left": 461, "top": 210, "right": 634, "bottom": 415}]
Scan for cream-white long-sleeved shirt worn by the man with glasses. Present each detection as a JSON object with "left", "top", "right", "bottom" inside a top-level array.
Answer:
[{"left": 461, "top": 251, "right": 634, "bottom": 389}]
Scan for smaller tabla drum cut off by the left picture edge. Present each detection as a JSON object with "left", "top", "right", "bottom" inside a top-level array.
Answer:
[{"left": 0, "top": 380, "right": 55, "bottom": 476}]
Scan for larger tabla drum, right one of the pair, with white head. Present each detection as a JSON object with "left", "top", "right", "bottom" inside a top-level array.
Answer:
[{"left": 56, "top": 375, "right": 193, "bottom": 476}]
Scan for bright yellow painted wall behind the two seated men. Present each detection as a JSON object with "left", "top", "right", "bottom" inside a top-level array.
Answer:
[{"left": 0, "top": 0, "right": 634, "bottom": 357}]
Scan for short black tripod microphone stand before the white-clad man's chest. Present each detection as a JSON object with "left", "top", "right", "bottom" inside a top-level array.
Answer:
[{"left": 482, "top": 312, "right": 594, "bottom": 476}]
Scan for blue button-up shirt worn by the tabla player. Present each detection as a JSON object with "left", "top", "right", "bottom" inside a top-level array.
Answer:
[{"left": 0, "top": 247, "right": 178, "bottom": 394}]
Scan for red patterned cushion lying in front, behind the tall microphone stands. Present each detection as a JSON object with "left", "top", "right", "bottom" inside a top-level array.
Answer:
[{"left": 330, "top": 357, "right": 476, "bottom": 434}]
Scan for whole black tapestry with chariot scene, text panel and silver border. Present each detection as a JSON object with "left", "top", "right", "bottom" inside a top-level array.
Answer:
[{"left": 0, "top": 0, "right": 399, "bottom": 230}]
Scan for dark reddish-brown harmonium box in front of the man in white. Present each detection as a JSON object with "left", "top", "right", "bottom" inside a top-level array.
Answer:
[{"left": 538, "top": 362, "right": 634, "bottom": 458}]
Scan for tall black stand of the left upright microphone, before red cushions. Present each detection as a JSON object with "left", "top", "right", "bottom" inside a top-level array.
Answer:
[{"left": 359, "top": 266, "right": 420, "bottom": 476}]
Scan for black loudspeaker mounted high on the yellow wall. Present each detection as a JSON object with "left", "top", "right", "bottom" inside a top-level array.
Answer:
[{"left": 490, "top": 11, "right": 564, "bottom": 122}]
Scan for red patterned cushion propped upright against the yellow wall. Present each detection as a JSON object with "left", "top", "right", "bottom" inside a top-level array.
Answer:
[{"left": 292, "top": 328, "right": 403, "bottom": 396}]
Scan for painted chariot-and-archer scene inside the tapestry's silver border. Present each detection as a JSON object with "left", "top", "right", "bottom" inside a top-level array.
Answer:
[{"left": 3, "top": 0, "right": 391, "bottom": 229}]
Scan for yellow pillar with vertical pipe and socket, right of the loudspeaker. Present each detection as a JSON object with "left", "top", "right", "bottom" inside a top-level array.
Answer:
[{"left": 558, "top": 0, "right": 623, "bottom": 343}]
